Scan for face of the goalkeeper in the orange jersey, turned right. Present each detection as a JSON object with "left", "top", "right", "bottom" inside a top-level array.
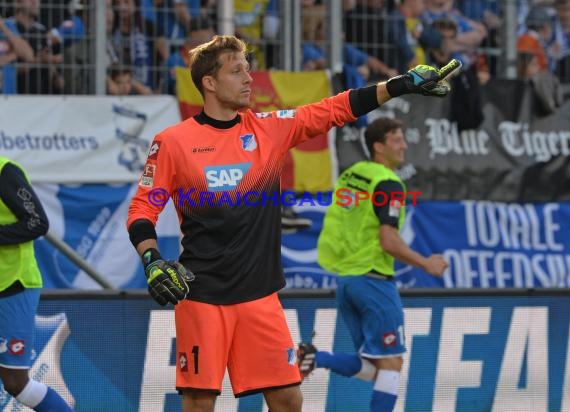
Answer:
[{"left": 211, "top": 52, "right": 253, "bottom": 110}]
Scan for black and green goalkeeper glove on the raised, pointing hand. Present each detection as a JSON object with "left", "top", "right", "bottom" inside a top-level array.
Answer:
[{"left": 386, "top": 59, "right": 462, "bottom": 97}]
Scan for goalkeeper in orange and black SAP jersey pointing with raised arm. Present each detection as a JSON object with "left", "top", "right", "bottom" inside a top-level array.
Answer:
[{"left": 127, "top": 36, "right": 459, "bottom": 412}]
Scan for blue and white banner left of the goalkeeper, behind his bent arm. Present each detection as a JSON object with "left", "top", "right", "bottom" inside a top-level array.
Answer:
[{"left": 34, "top": 183, "right": 180, "bottom": 289}]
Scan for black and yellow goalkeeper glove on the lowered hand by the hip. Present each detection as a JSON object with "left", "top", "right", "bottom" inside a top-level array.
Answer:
[{"left": 142, "top": 249, "right": 195, "bottom": 306}]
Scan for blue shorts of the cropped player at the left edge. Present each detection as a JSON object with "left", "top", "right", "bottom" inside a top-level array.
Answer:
[{"left": 0, "top": 289, "right": 40, "bottom": 369}]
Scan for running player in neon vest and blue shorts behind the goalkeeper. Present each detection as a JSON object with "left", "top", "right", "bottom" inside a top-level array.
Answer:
[{"left": 298, "top": 118, "right": 447, "bottom": 412}]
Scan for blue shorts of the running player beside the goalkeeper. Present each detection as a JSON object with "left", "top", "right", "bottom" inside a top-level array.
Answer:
[{"left": 336, "top": 276, "right": 406, "bottom": 359}]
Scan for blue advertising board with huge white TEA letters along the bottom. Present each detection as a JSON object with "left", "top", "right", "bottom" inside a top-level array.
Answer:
[{"left": 0, "top": 291, "right": 570, "bottom": 412}]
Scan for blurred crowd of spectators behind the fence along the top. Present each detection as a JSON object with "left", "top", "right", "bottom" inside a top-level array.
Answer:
[{"left": 0, "top": 0, "right": 570, "bottom": 95}]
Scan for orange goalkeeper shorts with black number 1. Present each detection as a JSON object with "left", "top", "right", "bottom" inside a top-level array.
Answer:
[{"left": 175, "top": 293, "right": 301, "bottom": 397}]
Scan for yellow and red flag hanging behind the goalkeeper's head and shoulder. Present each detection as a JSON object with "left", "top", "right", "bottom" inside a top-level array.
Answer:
[{"left": 176, "top": 67, "right": 333, "bottom": 193}]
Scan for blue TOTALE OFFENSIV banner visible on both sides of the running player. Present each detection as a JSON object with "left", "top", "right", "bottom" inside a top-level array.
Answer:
[{"left": 282, "top": 201, "right": 570, "bottom": 288}]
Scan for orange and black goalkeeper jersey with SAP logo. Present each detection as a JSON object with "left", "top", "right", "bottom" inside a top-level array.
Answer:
[{"left": 127, "top": 92, "right": 356, "bottom": 304}]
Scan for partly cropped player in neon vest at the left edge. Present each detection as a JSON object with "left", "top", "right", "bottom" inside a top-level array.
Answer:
[{"left": 0, "top": 156, "right": 72, "bottom": 412}]
